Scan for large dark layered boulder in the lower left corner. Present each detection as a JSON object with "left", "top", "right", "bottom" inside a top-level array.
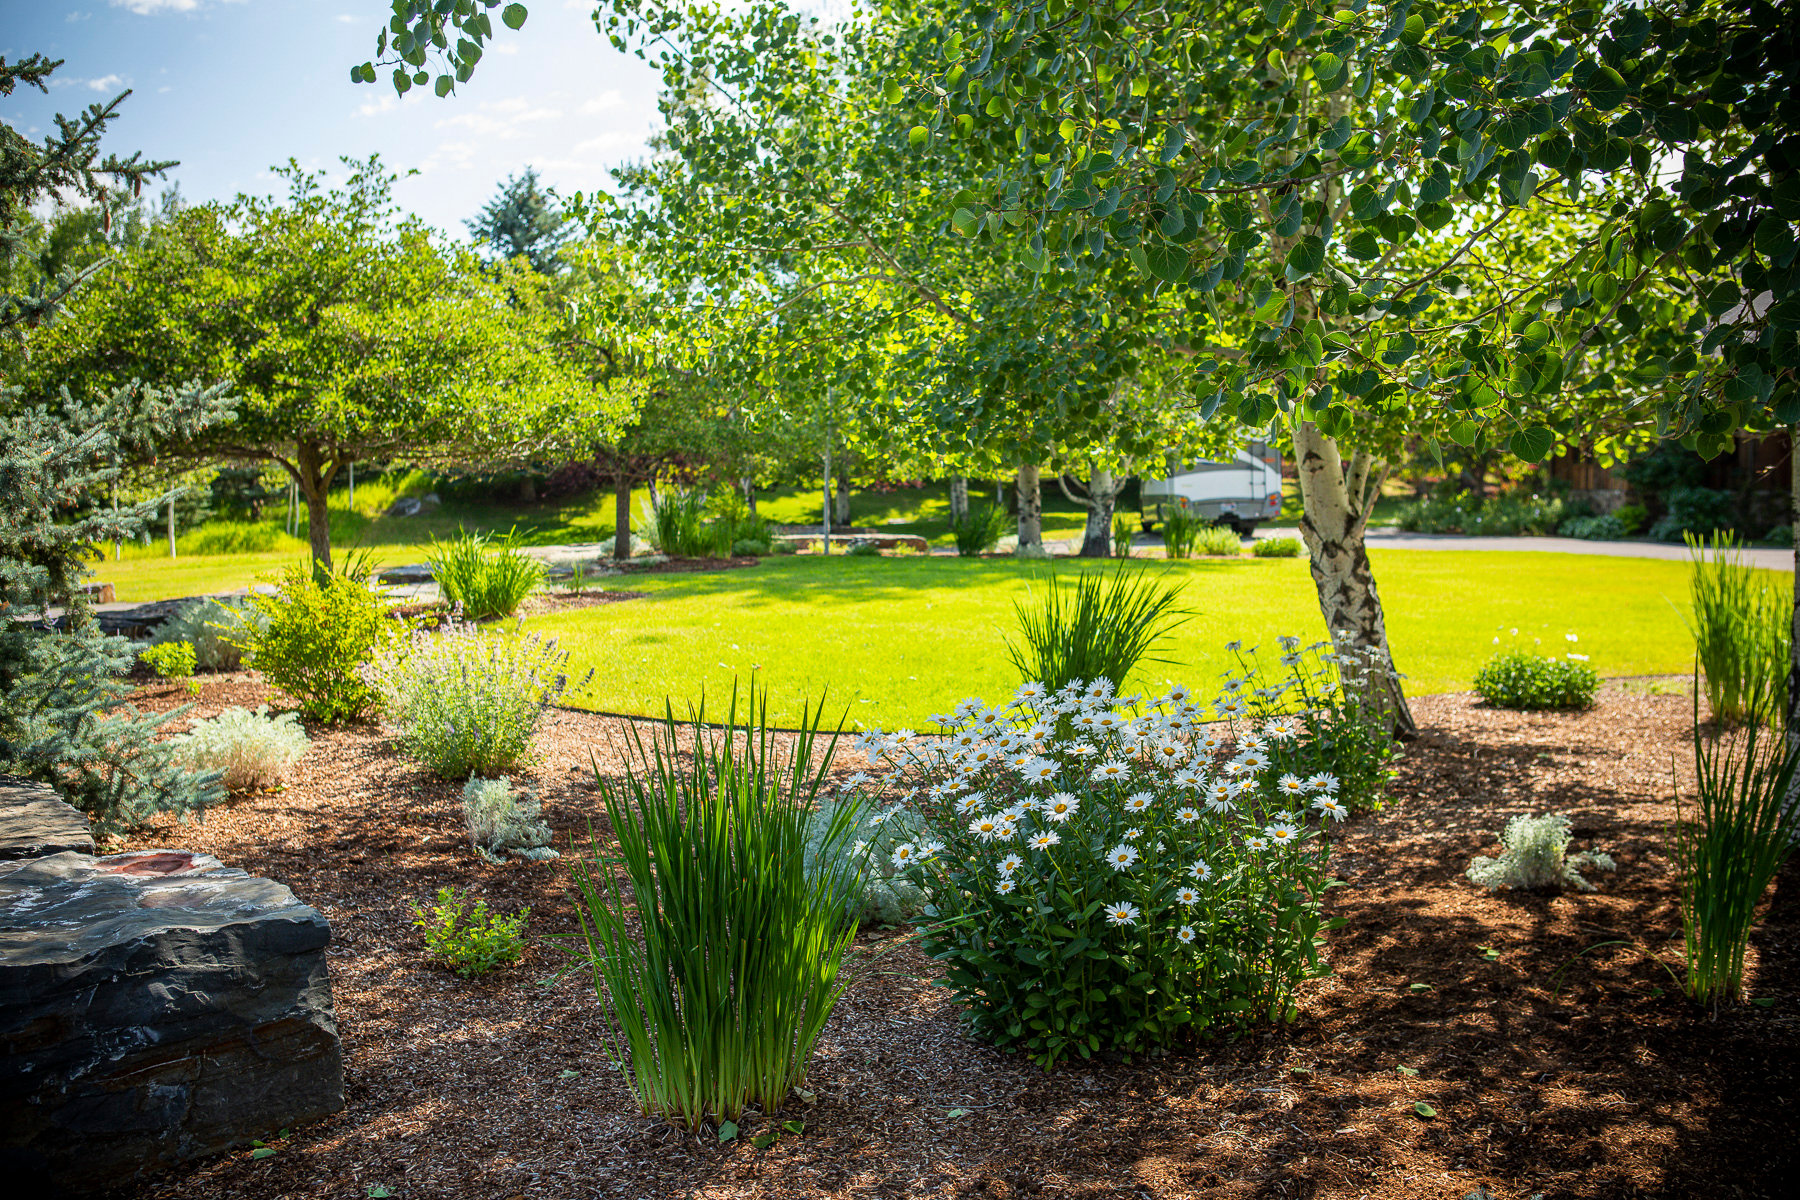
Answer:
[{"left": 0, "top": 851, "right": 344, "bottom": 1195}]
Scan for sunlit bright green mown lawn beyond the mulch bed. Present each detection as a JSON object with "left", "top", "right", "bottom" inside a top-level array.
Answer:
[{"left": 527, "top": 551, "right": 1720, "bottom": 729}]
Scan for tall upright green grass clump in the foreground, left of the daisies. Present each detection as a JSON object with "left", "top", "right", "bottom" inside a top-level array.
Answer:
[{"left": 574, "top": 691, "right": 864, "bottom": 1130}]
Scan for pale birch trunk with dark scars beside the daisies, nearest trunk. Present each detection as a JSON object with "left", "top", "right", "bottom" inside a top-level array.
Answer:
[{"left": 1294, "top": 421, "right": 1418, "bottom": 736}]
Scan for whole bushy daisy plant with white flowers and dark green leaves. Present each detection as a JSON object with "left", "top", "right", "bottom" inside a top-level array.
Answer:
[{"left": 862, "top": 678, "right": 1348, "bottom": 1069}]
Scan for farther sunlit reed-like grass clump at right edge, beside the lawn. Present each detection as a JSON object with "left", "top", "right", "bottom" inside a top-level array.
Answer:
[{"left": 1687, "top": 533, "right": 1793, "bottom": 725}]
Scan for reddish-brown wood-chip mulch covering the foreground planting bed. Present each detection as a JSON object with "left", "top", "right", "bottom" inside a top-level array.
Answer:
[{"left": 116, "top": 676, "right": 1800, "bottom": 1200}]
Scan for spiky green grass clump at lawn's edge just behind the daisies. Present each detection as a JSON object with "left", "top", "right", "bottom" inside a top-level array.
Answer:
[{"left": 1006, "top": 561, "right": 1190, "bottom": 691}]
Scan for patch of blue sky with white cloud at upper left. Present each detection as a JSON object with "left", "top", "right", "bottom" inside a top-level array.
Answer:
[{"left": 0, "top": 0, "right": 657, "bottom": 236}]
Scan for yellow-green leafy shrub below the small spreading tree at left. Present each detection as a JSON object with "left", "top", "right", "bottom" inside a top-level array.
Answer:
[{"left": 229, "top": 567, "right": 403, "bottom": 725}]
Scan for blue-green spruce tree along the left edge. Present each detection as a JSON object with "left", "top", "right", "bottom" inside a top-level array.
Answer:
[{"left": 0, "top": 54, "right": 227, "bottom": 829}]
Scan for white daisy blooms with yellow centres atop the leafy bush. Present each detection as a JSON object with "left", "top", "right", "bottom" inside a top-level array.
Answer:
[{"left": 848, "top": 672, "right": 1348, "bottom": 943}]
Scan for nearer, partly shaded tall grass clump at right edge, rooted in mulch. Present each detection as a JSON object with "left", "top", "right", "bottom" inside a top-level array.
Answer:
[{"left": 1674, "top": 680, "right": 1800, "bottom": 1011}]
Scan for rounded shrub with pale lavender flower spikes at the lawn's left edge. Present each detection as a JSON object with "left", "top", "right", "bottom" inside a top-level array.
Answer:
[{"left": 365, "top": 622, "right": 569, "bottom": 779}]
